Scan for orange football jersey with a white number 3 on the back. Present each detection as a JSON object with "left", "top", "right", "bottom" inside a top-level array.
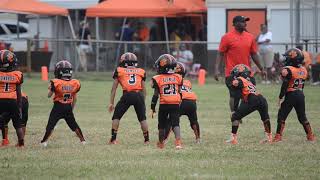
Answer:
[{"left": 113, "top": 67, "right": 146, "bottom": 92}]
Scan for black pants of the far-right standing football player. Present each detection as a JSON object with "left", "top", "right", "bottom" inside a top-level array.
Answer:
[{"left": 278, "top": 90, "right": 307, "bottom": 122}]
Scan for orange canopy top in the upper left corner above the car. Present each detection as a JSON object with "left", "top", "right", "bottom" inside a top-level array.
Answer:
[{"left": 0, "top": 0, "right": 69, "bottom": 16}]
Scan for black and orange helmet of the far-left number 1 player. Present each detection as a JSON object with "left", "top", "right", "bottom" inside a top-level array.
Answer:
[{"left": 0, "top": 50, "right": 18, "bottom": 71}]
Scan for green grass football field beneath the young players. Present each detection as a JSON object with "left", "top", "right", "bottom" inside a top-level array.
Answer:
[{"left": 0, "top": 73, "right": 320, "bottom": 179}]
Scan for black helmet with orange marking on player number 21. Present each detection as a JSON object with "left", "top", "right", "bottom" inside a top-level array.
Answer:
[{"left": 154, "top": 54, "right": 177, "bottom": 74}]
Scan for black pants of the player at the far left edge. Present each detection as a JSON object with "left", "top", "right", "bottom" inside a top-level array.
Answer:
[{"left": 0, "top": 99, "right": 21, "bottom": 129}]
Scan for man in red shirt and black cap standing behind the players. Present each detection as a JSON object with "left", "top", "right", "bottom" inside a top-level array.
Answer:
[{"left": 214, "top": 16, "right": 265, "bottom": 112}]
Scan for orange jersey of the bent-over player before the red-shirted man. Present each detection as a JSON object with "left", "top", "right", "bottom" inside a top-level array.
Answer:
[{"left": 232, "top": 77, "right": 259, "bottom": 102}]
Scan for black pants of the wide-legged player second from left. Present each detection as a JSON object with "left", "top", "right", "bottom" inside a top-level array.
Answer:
[{"left": 46, "top": 102, "right": 79, "bottom": 131}]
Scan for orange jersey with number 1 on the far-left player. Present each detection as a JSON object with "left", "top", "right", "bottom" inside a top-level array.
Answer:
[{"left": 0, "top": 71, "right": 23, "bottom": 99}]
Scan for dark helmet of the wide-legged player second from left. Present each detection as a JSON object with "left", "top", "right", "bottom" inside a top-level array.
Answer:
[{"left": 54, "top": 60, "right": 72, "bottom": 80}]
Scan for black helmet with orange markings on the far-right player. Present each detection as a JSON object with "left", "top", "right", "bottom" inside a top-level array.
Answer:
[{"left": 283, "top": 48, "right": 304, "bottom": 66}]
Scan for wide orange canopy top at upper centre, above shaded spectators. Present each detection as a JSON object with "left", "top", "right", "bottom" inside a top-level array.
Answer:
[{"left": 86, "top": 0, "right": 185, "bottom": 17}]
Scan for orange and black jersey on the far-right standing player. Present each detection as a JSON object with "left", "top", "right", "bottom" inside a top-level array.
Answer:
[{"left": 285, "top": 66, "right": 308, "bottom": 92}]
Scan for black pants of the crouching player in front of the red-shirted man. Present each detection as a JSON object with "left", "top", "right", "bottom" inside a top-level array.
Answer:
[{"left": 231, "top": 94, "right": 270, "bottom": 121}]
